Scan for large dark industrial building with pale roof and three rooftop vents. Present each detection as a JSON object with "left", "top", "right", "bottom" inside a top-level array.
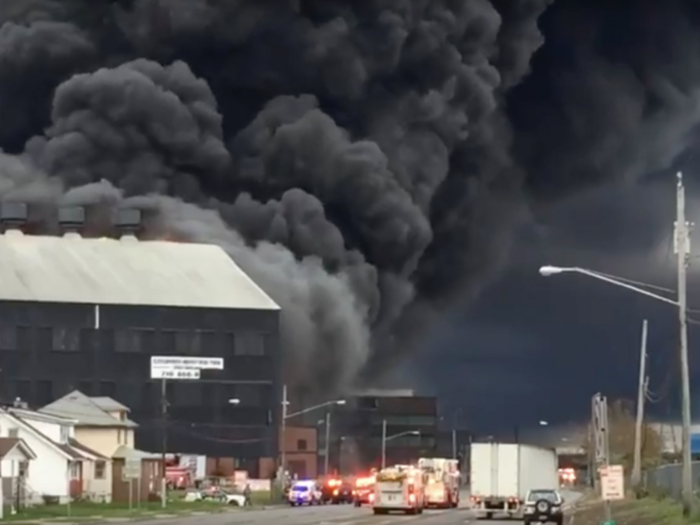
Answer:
[{"left": 0, "top": 204, "right": 280, "bottom": 468}]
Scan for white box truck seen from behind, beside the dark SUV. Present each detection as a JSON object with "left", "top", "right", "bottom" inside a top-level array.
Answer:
[{"left": 470, "top": 443, "right": 559, "bottom": 519}]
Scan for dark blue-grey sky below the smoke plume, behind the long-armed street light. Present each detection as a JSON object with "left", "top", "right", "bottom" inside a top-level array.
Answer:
[{"left": 406, "top": 178, "right": 700, "bottom": 431}]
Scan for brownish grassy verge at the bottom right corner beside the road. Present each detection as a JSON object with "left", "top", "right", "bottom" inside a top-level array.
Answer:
[{"left": 570, "top": 498, "right": 700, "bottom": 525}]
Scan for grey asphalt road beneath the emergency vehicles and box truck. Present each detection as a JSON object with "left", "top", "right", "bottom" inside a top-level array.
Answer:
[{"left": 129, "top": 492, "right": 580, "bottom": 525}]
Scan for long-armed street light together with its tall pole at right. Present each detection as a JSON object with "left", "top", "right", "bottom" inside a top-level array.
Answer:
[{"left": 540, "top": 260, "right": 692, "bottom": 515}]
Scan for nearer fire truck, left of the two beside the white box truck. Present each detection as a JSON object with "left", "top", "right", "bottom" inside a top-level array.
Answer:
[{"left": 370, "top": 465, "right": 425, "bottom": 514}]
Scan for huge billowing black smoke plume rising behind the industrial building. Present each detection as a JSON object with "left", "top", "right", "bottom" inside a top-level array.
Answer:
[{"left": 0, "top": 0, "right": 700, "bottom": 390}]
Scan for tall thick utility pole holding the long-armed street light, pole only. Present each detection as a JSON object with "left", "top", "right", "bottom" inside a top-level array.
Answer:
[{"left": 674, "top": 172, "right": 693, "bottom": 517}]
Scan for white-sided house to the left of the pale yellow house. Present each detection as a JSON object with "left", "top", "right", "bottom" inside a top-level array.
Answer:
[{"left": 0, "top": 408, "right": 106, "bottom": 503}]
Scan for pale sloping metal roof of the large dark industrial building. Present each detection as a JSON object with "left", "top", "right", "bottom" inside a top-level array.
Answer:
[{"left": 0, "top": 230, "right": 279, "bottom": 310}]
